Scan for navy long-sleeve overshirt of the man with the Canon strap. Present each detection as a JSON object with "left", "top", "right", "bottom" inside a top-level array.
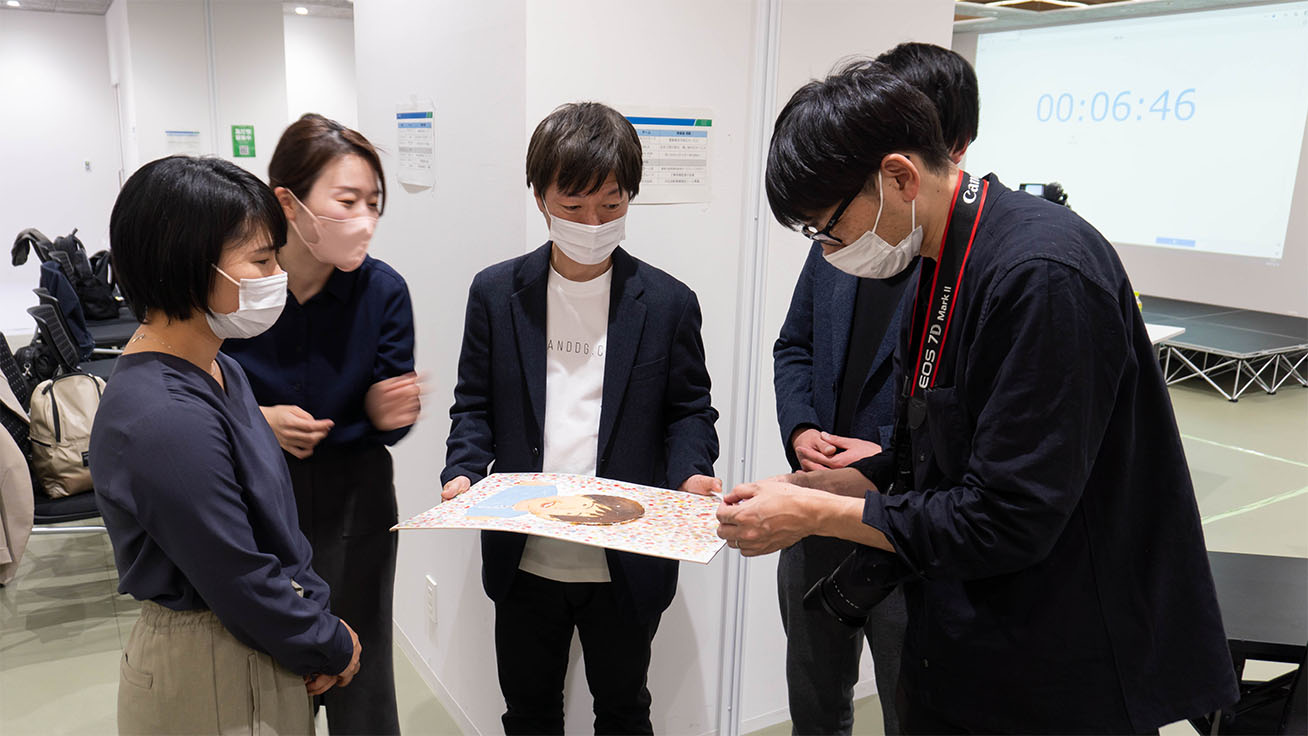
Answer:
[{"left": 855, "top": 175, "right": 1237, "bottom": 733}]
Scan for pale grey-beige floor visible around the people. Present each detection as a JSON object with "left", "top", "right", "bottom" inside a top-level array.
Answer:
[{"left": 0, "top": 386, "right": 1308, "bottom": 736}]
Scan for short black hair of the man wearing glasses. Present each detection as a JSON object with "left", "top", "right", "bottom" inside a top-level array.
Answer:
[{"left": 765, "top": 59, "right": 950, "bottom": 229}]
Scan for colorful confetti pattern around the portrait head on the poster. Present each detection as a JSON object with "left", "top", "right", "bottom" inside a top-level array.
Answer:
[{"left": 395, "top": 473, "right": 725, "bottom": 565}]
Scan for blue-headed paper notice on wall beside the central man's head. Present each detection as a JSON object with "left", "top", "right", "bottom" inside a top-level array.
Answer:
[{"left": 623, "top": 107, "right": 713, "bottom": 204}]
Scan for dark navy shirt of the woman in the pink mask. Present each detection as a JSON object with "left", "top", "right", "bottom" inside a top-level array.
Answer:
[{"left": 222, "top": 256, "right": 413, "bottom": 447}]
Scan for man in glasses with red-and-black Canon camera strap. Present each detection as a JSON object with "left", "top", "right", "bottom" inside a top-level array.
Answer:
[{"left": 718, "top": 63, "right": 1239, "bottom": 733}]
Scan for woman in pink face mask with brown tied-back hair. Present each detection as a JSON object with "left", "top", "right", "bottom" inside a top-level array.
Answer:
[{"left": 226, "top": 114, "right": 420, "bottom": 733}]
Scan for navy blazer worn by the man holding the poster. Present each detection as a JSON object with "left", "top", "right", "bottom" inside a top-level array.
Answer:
[{"left": 441, "top": 243, "right": 718, "bottom": 620}]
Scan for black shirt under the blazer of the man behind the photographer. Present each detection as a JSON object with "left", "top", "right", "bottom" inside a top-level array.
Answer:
[{"left": 835, "top": 268, "right": 914, "bottom": 434}]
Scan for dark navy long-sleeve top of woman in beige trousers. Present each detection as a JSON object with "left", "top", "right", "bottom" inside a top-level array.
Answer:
[{"left": 90, "top": 353, "right": 353, "bottom": 675}]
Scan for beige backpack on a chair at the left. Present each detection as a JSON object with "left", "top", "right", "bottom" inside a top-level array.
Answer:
[{"left": 29, "top": 373, "right": 105, "bottom": 498}]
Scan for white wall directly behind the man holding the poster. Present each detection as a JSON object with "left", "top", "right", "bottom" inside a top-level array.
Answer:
[{"left": 354, "top": 0, "right": 952, "bottom": 733}]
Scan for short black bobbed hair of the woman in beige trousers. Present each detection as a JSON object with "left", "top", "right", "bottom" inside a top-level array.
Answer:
[{"left": 109, "top": 156, "right": 286, "bottom": 322}]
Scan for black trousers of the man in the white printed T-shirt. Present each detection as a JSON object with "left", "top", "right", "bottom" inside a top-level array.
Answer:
[{"left": 494, "top": 570, "right": 658, "bottom": 733}]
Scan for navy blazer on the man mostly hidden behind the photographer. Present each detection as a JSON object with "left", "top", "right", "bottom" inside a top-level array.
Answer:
[{"left": 772, "top": 243, "right": 917, "bottom": 469}]
